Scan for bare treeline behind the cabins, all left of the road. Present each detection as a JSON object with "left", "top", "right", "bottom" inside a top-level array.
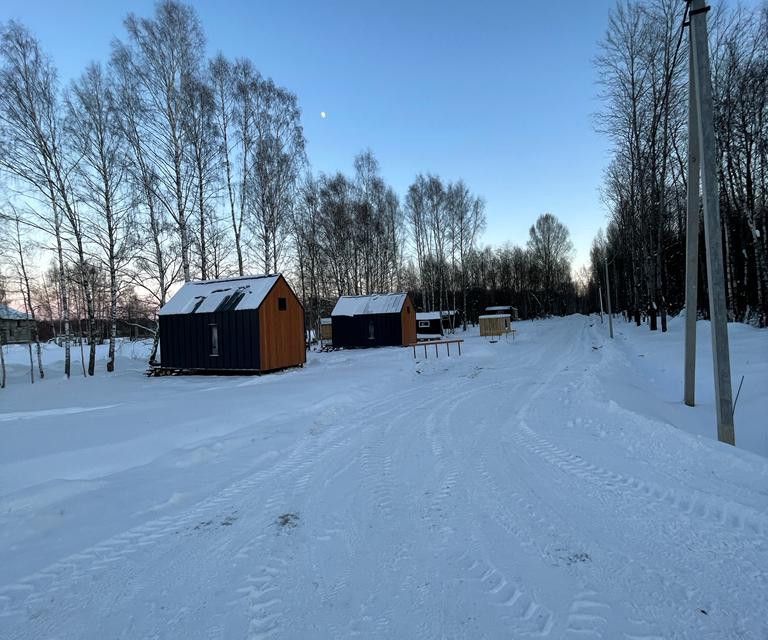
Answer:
[{"left": 0, "top": 0, "right": 575, "bottom": 375}]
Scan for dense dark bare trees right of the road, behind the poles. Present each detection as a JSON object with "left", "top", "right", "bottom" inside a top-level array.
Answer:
[{"left": 591, "top": 0, "right": 768, "bottom": 329}]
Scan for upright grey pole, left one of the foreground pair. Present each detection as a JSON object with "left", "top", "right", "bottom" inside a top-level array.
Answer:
[{"left": 683, "top": 11, "right": 701, "bottom": 407}]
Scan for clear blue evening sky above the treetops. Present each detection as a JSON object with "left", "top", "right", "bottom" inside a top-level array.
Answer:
[{"left": 0, "top": 0, "right": 614, "bottom": 265}]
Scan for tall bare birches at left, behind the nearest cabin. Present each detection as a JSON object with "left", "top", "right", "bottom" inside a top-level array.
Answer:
[{"left": 0, "top": 0, "right": 305, "bottom": 375}]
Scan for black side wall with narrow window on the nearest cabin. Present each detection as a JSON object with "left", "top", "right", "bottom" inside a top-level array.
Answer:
[{"left": 160, "top": 309, "right": 261, "bottom": 371}]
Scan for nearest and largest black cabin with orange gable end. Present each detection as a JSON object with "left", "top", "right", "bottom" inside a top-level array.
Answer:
[{"left": 159, "top": 274, "right": 306, "bottom": 373}]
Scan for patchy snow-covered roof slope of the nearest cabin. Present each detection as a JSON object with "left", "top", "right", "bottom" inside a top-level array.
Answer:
[{"left": 159, "top": 274, "right": 280, "bottom": 316}]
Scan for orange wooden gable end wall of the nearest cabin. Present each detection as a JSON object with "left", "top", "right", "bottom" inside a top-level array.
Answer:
[{"left": 259, "top": 276, "right": 306, "bottom": 371}]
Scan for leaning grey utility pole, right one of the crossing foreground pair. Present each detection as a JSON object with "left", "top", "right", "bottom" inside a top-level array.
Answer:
[{"left": 686, "top": 0, "right": 735, "bottom": 445}]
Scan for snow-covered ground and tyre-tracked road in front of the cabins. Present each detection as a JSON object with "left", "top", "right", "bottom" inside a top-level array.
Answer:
[{"left": 0, "top": 317, "right": 768, "bottom": 639}]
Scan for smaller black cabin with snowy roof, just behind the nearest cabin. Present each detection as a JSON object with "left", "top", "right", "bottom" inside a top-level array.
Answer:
[{"left": 331, "top": 293, "right": 416, "bottom": 348}]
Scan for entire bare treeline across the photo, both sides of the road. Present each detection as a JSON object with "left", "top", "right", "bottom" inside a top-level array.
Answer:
[{"left": 0, "top": 0, "right": 768, "bottom": 382}]
